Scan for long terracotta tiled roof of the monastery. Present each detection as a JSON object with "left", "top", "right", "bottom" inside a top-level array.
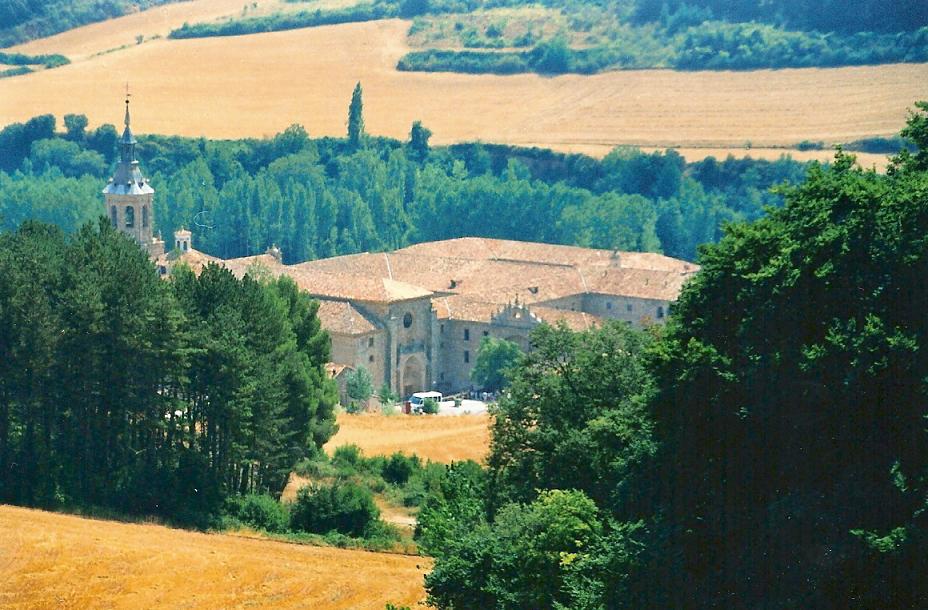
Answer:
[{"left": 210, "top": 237, "right": 699, "bottom": 318}]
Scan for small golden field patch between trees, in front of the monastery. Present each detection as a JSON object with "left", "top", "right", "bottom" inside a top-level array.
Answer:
[{"left": 325, "top": 413, "right": 490, "bottom": 462}]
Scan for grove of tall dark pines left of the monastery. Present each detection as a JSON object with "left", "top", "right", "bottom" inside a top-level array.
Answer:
[{"left": 0, "top": 219, "right": 337, "bottom": 522}]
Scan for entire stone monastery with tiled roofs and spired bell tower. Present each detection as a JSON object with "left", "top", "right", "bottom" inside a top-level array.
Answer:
[{"left": 104, "top": 103, "right": 698, "bottom": 397}]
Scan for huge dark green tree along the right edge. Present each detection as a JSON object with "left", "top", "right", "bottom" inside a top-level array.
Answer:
[{"left": 651, "top": 105, "right": 928, "bottom": 608}]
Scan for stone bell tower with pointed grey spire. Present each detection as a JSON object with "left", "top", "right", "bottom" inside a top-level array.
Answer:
[{"left": 103, "top": 97, "right": 164, "bottom": 258}]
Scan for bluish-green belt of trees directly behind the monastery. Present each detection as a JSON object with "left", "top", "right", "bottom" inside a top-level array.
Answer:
[{"left": 0, "top": 115, "right": 820, "bottom": 262}]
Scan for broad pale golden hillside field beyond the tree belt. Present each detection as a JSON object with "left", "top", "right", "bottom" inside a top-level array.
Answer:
[{"left": 0, "top": 0, "right": 928, "bottom": 165}]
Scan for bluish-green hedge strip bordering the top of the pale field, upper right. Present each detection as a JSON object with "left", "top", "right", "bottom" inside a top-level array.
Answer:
[{"left": 397, "top": 18, "right": 928, "bottom": 74}]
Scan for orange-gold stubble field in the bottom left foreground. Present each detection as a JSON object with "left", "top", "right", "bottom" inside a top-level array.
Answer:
[{"left": 0, "top": 506, "right": 431, "bottom": 610}]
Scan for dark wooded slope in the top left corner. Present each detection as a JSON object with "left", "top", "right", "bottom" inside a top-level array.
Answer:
[{"left": 0, "top": 0, "right": 178, "bottom": 48}]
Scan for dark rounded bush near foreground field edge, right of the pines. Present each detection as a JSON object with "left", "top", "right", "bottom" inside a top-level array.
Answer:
[{"left": 290, "top": 481, "right": 380, "bottom": 537}]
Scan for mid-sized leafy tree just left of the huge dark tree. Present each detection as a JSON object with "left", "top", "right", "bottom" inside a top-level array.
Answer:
[{"left": 487, "top": 322, "right": 656, "bottom": 514}]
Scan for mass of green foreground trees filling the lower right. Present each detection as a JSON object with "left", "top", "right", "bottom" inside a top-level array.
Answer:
[{"left": 417, "top": 102, "right": 928, "bottom": 609}]
